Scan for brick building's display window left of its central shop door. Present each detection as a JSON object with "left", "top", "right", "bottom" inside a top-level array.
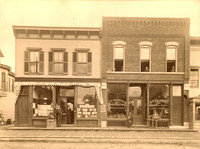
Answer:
[{"left": 108, "top": 84, "right": 127, "bottom": 118}]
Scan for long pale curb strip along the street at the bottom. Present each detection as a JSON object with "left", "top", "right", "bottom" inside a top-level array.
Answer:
[{"left": 0, "top": 137, "right": 200, "bottom": 144}]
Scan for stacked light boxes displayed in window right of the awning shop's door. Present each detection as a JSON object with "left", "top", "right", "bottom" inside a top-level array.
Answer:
[{"left": 77, "top": 104, "right": 97, "bottom": 118}]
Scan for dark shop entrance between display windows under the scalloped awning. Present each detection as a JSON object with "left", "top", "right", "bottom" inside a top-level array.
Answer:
[{"left": 59, "top": 88, "right": 75, "bottom": 124}]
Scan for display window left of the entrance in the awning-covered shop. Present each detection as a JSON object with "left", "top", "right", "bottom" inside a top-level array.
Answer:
[{"left": 33, "top": 86, "right": 53, "bottom": 118}]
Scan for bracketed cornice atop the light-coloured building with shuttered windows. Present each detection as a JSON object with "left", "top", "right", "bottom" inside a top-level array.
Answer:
[{"left": 13, "top": 26, "right": 101, "bottom": 40}]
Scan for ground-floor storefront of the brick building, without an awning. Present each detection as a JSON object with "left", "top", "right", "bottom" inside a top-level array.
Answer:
[{"left": 107, "top": 83, "right": 184, "bottom": 127}]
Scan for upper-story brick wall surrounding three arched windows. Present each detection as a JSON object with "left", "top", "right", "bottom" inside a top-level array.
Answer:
[{"left": 102, "top": 17, "right": 189, "bottom": 80}]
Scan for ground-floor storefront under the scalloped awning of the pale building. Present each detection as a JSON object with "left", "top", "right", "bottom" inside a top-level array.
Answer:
[{"left": 16, "top": 82, "right": 103, "bottom": 127}]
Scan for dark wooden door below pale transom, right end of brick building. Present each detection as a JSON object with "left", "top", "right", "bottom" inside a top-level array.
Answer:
[{"left": 172, "top": 97, "right": 183, "bottom": 125}]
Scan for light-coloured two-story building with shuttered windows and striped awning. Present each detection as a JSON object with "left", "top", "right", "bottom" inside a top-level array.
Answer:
[{"left": 13, "top": 26, "right": 103, "bottom": 126}]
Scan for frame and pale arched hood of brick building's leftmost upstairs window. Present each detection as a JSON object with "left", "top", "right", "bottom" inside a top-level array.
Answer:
[{"left": 112, "top": 41, "right": 126, "bottom": 72}]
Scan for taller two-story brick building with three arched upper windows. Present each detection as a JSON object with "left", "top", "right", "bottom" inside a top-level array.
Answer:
[{"left": 102, "top": 17, "right": 190, "bottom": 128}]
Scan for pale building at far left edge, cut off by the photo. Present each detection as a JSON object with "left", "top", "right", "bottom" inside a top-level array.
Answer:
[{"left": 0, "top": 50, "right": 16, "bottom": 122}]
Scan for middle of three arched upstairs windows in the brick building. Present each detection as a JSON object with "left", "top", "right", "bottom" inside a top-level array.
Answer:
[{"left": 139, "top": 41, "right": 152, "bottom": 72}]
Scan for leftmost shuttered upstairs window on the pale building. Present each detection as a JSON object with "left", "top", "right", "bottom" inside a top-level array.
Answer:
[{"left": 24, "top": 48, "right": 44, "bottom": 74}]
